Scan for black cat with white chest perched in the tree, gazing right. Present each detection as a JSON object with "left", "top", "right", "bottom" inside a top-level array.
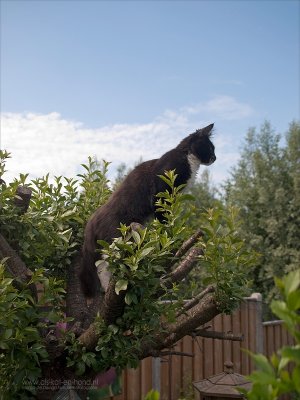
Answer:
[{"left": 80, "top": 124, "right": 216, "bottom": 297}]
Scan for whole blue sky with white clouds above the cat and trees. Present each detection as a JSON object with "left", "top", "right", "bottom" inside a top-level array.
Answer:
[{"left": 1, "top": 0, "right": 300, "bottom": 184}]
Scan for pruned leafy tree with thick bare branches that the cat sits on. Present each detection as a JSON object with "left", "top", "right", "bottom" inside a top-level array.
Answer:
[{"left": 0, "top": 152, "right": 252, "bottom": 399}]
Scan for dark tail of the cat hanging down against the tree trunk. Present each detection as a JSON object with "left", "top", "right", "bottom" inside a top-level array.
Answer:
[{"left": 79, "top": 247, "right": 100, "bottom": 298}]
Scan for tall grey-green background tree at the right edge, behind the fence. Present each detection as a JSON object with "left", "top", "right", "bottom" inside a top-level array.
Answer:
[{"left": 225, "top": 122, "right": 300, "bottom": 310}]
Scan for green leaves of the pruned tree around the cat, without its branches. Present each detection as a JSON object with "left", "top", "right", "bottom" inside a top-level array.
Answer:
[{"left": 0, "top": 152, "right": 253, "bottom": 399}]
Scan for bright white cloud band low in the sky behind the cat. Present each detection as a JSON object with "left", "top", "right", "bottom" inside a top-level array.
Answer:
[{"left": 1, "top": 96, "right": 252, "bottom": 181}]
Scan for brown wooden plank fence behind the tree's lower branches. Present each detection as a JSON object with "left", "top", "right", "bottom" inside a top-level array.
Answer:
[{"left": 111, "top": 294, "right": 292, "bottom": 400}]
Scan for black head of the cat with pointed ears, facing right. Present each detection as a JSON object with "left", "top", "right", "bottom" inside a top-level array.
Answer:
[{"left": 179, "top": 124, "right": 216, "bottom": 165}]
